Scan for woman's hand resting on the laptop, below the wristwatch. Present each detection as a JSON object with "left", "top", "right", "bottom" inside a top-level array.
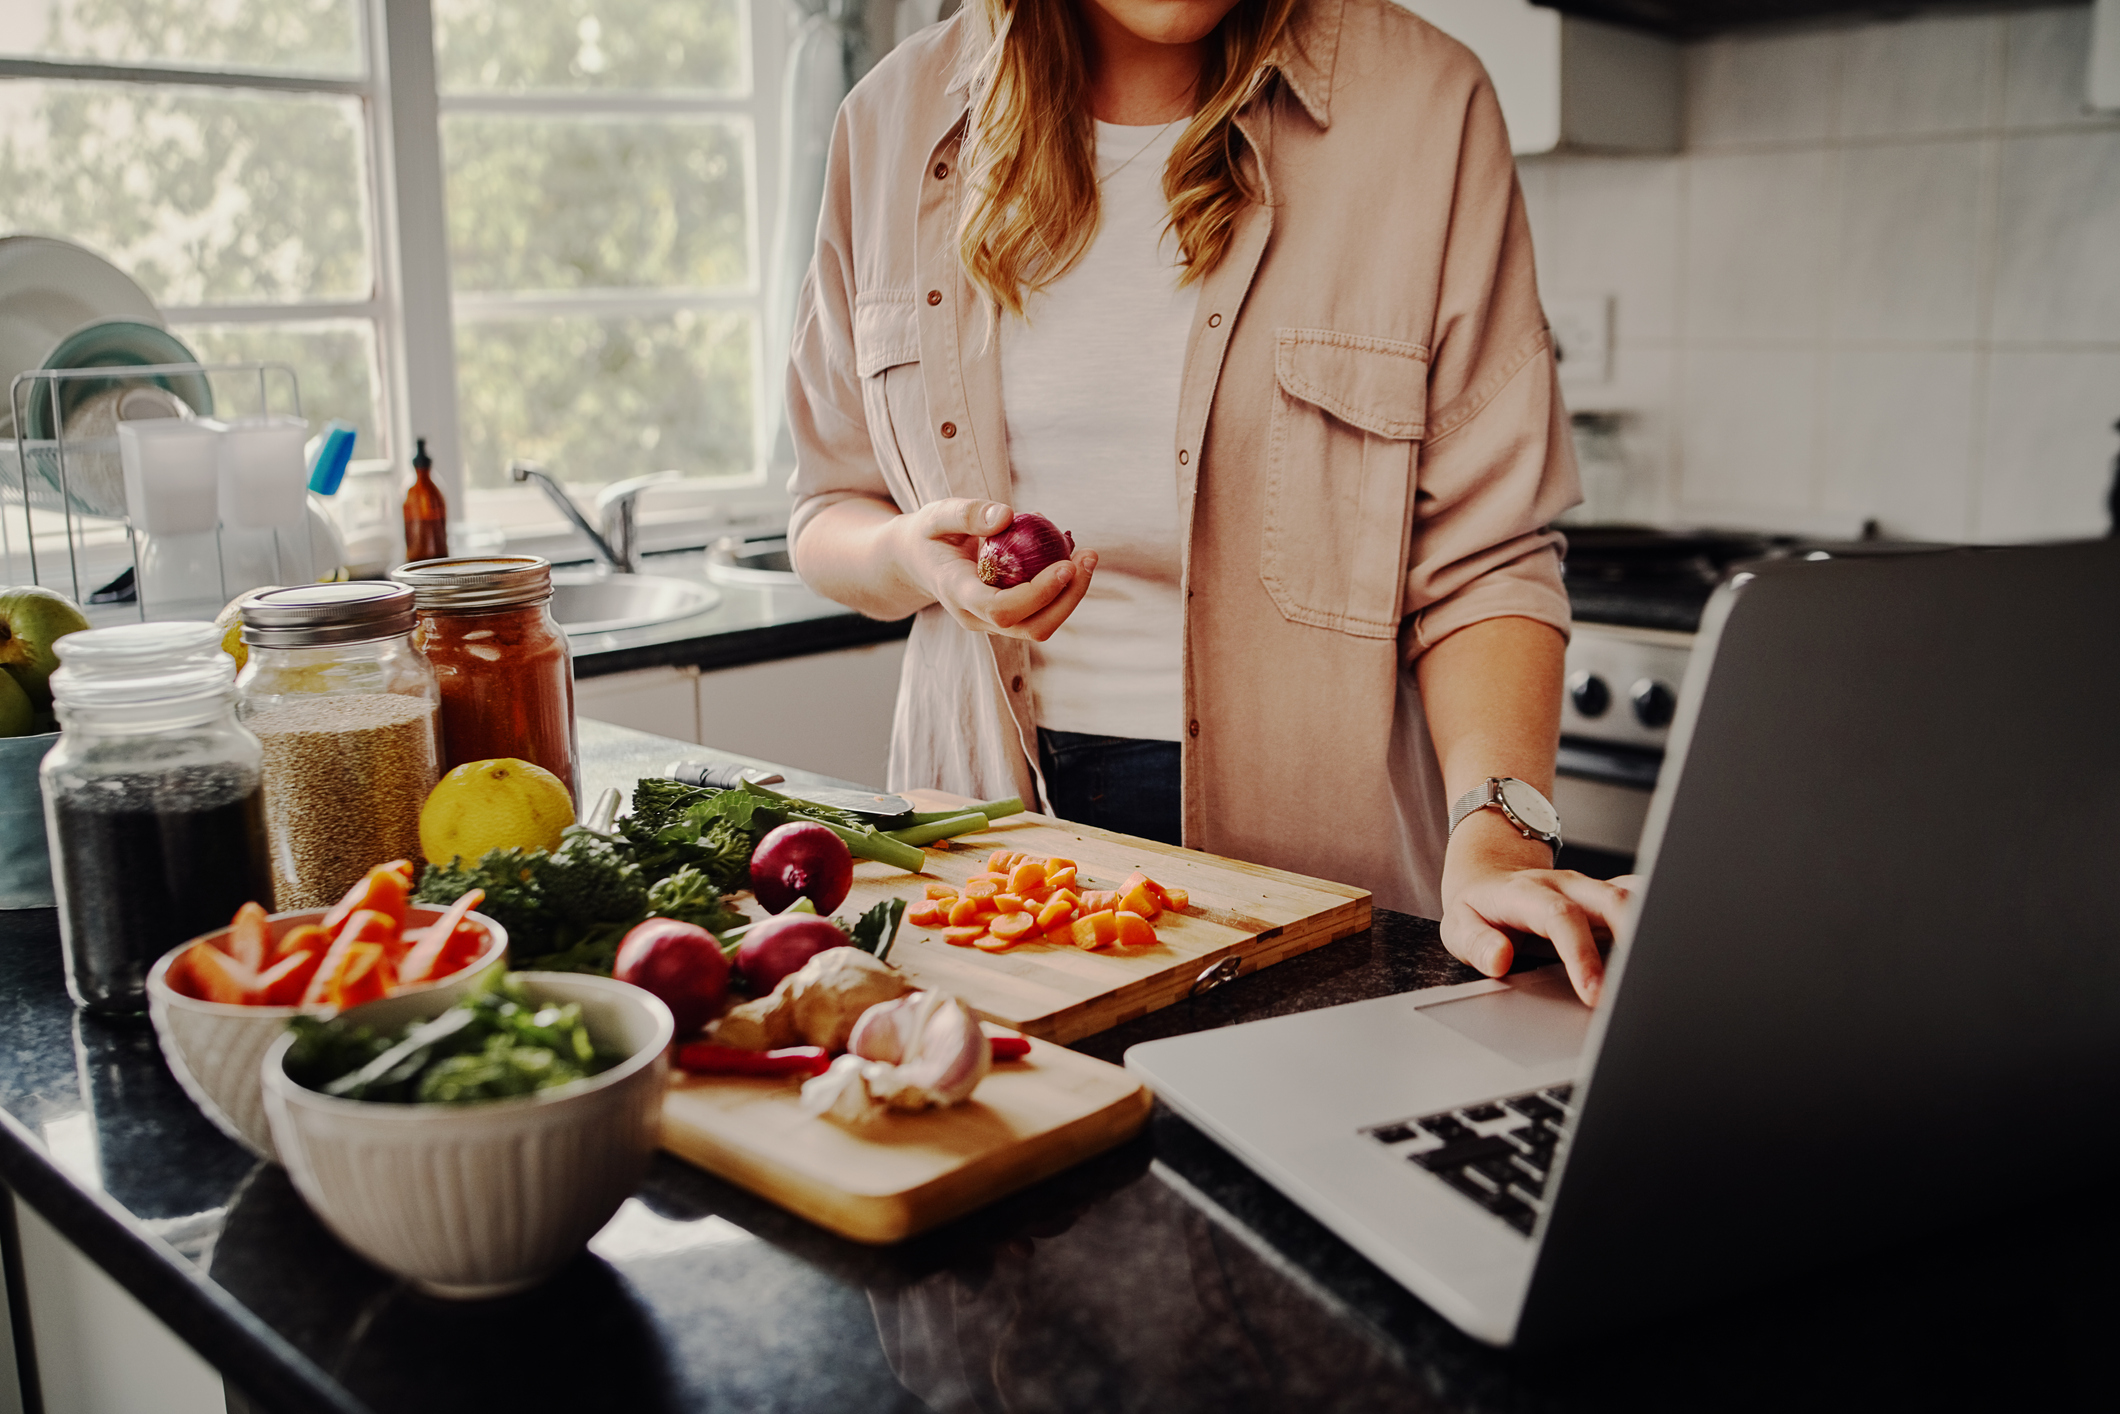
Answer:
[{"left": 1444, "top": 810, "right": 1641, "bottom": 1005}]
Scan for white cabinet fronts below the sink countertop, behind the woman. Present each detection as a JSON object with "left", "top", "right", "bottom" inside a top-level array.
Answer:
[{"left": 575, "top": 638, "right": 905, "bottom": 786}]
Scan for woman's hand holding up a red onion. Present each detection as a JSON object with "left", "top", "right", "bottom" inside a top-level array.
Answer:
[{"left": 890, "top": 498, "right": 1096, "bottom": 642}]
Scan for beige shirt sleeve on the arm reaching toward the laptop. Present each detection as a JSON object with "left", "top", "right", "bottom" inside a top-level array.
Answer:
[{"left": 1401, "top": 72, "right": 1582, "bottom": 659}]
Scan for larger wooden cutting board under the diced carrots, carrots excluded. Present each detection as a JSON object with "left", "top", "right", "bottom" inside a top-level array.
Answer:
[{"left": 805, "top": 791, "right": 1370, "bottom": 1045}]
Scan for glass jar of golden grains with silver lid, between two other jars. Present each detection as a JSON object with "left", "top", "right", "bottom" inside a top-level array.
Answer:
[{"left": 235, "top": 581, "right": 441, "bottom": 909}]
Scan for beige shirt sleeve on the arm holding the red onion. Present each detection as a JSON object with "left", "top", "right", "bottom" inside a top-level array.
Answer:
[{"left": 787, "top": 108, "right": 890, "bottom": 545}]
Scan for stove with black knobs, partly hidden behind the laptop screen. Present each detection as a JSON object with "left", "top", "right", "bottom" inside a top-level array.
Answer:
[{"left": 1554, "top": 526, "right": 1940, "bottom": 867}]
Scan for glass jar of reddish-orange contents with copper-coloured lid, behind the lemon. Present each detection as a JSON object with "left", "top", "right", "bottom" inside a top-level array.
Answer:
[{"left": 390, "top": 555, "right": 581, "bottom": 810}]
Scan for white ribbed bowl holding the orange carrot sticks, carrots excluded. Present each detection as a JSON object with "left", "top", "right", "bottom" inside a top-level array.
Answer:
[{"left": 146, "top": 903, "right": 509, "bottom": 1164}]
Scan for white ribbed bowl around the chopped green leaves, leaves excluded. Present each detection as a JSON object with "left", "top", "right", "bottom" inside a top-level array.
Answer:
[{"left": 263, "top": 973, "right": 674, "bottom": 1300}]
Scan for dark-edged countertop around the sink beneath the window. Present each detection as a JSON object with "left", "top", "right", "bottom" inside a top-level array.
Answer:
[{"left": 560, "top": 549, "right": 912, "bottom": 678}]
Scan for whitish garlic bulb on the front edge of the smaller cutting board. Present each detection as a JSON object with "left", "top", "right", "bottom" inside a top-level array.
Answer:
[{"left": 801, "top": 992, "right": 994, "bottom": 1124}]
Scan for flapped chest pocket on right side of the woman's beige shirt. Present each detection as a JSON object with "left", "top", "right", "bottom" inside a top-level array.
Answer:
[{"left": 1259, "top": 329, "right": 1429, "bottom": 638}]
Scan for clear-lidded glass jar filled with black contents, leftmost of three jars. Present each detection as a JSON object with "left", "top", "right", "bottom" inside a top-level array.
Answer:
[{"left": 40, "top": 623, "right": 273, "bottom": 1013}]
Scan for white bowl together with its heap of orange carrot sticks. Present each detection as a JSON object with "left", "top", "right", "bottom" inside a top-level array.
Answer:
[{"left": 146, "top": 861, "right": 509, "bottom": 1162}]
